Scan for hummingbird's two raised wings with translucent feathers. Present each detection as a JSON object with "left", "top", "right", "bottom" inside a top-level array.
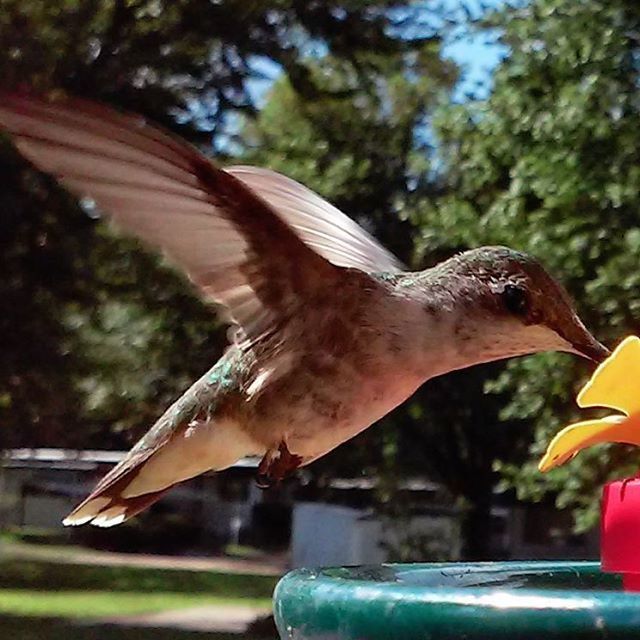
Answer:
[{"left": 0, "top": 95, "right": 397, "bottom": 341}]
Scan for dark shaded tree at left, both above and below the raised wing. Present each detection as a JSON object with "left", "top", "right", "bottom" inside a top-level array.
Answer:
[{"left": 0, "top": 0, "right": 450, "bottom": 447}]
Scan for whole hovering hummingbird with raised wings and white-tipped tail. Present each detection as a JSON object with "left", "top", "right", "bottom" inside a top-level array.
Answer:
[{"left": 0, "top": 94, "right": 609, "bottom": 527}]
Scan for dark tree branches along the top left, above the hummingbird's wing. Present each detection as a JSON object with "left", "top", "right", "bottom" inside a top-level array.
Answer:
[{"left": 0, "top": 0, "right": 458, "bottom": 144}]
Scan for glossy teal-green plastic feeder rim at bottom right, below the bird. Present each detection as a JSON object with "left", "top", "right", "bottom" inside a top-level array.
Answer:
[{"left": 274, "top": 562, "right": 640, "bottom": 640}]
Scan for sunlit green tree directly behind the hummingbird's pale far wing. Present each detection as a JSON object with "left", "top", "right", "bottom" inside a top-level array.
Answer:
[{"left": 242, "top": 52, "right": 456, "bottom": 263}]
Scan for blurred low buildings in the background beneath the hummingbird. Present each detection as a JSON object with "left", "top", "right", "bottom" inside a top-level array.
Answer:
[{"left": 0, "top": 449, "right": 598, "bottom": 567}]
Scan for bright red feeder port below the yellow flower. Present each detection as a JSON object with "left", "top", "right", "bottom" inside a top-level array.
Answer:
[{"left": 600, "top": 478, "right": 640, "bottom": 591}]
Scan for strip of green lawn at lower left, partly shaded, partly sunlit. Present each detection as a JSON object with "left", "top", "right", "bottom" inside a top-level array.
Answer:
[{"left": 0, "top": 557, "right": 277, "bottom": 620}]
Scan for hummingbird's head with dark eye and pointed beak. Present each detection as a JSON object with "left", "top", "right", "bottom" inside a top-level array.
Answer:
[{"left": 422, "top": 247, "right": 609, "bottom": 362}]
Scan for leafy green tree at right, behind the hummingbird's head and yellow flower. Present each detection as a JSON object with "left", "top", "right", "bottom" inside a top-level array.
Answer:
[{"left": 422, "top": 0, "right": 640, "bottom": 530}]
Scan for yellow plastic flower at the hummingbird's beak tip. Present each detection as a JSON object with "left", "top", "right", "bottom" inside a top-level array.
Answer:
[{"left": 538, "top": 336, "right": 640, "bottom": 472}]
